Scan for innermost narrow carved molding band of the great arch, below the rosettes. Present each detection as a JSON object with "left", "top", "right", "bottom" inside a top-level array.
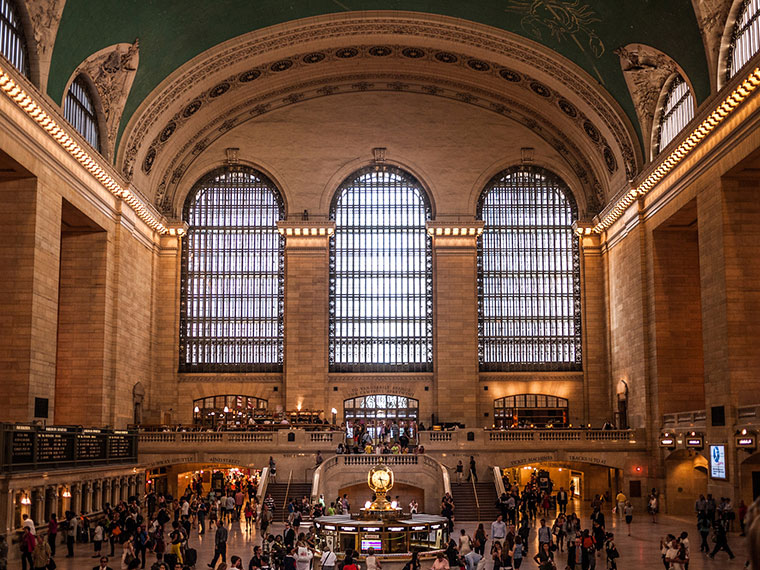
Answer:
[{"left": 155, "top": 72, "right": 606, "bottom": 215}]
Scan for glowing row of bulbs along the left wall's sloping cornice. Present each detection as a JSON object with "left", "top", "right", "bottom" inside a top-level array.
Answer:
[{"left": 0, "top": 67, "right": 169, "bottom": 234}]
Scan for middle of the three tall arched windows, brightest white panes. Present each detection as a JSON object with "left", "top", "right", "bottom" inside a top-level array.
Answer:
[{"left": 330, "top": 166, "right": 433, "bottom": 372}]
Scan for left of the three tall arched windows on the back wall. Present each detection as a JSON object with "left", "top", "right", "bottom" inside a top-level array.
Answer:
[{"left": 179, "top": 166, "right": 284, "bottom": 372}]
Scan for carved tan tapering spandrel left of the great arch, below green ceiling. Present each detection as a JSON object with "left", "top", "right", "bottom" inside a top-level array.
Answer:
[{"left": 72, "top": 40, "right": 140, "bottom": 158}]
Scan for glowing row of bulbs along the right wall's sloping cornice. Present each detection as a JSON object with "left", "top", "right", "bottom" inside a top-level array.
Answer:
[{"left": 594, "top": 67, "right": 760, "bottom": 233}]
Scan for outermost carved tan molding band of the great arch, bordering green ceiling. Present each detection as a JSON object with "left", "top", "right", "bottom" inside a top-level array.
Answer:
[{"left": 118, "top": 14, "right": 642, "bottom": 184}]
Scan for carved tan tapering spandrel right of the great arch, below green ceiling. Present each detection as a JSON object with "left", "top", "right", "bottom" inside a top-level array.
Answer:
[{"left": 615, "top": 44, "right": 680, "bottom": 160}]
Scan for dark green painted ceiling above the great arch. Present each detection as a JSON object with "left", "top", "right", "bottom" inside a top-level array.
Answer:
[{"left": 48, "top": 0, "right": 710, "bottom": 146}]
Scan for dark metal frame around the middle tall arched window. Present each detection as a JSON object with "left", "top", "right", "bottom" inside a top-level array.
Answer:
[{"left": 328, "top": 165, "right": 434, "bottom": 372}]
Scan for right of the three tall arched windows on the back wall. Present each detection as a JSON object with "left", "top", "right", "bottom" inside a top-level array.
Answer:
[{"left": 478, "top": 167, "right": 581, "bottom": 371}]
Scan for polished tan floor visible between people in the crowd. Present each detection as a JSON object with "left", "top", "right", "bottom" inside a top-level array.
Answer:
[{"left": 49, "top": 504, "right": 747, "bottom": 570}]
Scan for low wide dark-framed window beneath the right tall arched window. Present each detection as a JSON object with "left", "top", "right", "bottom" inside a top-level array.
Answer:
[{"left": 493, "top": 394, "right": 568, "bottom": 428}]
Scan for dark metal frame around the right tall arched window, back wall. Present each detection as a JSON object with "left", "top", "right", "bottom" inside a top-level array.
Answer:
[{"left": 477, "top": 165, "right": 583, "bottom": 372}]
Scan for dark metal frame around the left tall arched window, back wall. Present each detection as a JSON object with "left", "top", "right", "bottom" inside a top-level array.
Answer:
[{"left": 178, "top": 165, "right": 285, "bottom": 373}]
